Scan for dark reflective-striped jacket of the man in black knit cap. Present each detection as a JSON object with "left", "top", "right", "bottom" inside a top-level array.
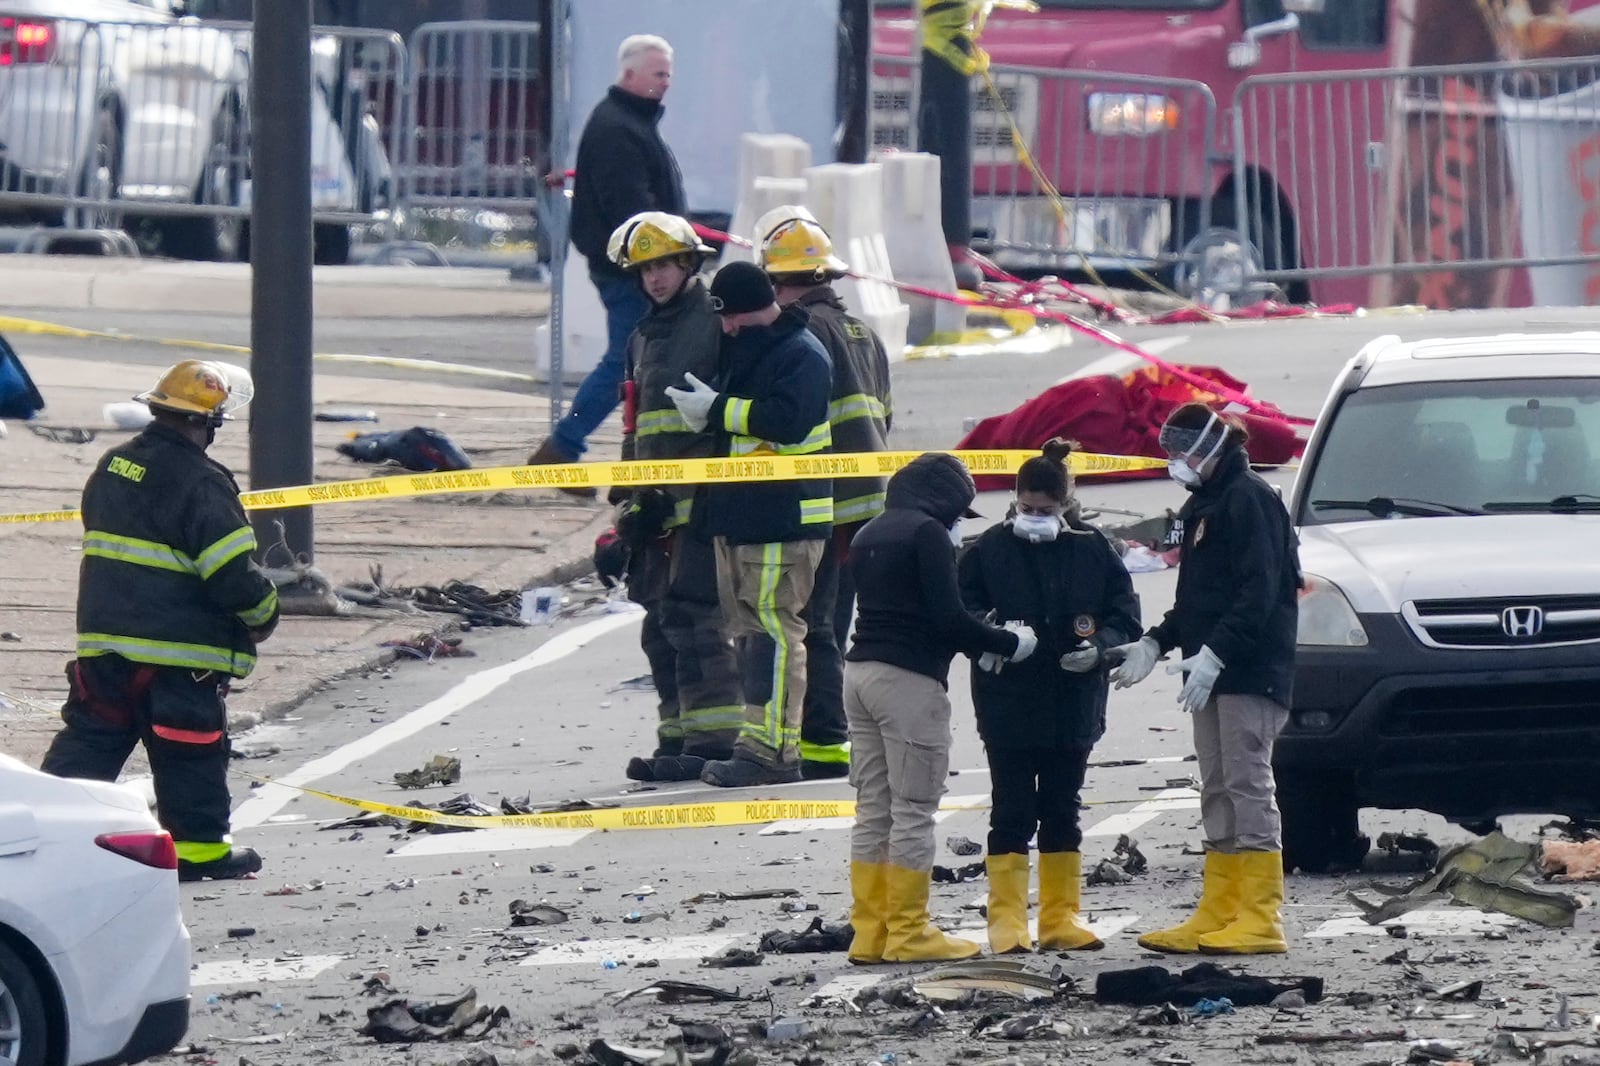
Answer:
[{"left": 694, "top": 311, "right": 834, "bottom": 544}]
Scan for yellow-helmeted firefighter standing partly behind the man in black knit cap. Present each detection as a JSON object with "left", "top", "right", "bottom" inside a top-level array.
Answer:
[{"left": 755, "top": 205, "right": 893, "bottom": 778}]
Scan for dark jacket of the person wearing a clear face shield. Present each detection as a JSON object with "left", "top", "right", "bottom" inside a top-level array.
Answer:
[{"left": 1149, "top": 450, "right": 1301, "bottom": 707}]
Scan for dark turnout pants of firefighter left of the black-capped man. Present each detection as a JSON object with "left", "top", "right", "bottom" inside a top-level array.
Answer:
[{"left": 629, "top": 527, "right": 744, "bottom": 759}]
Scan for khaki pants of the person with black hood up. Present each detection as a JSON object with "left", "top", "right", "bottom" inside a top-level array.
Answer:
[{"left": 845, "top": 663, "right": 950, "bottom": 871}]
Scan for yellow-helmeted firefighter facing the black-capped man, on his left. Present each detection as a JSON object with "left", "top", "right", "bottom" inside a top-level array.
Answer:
[{"left": 608, "top": 211, "right": 744, "bottom": 781}]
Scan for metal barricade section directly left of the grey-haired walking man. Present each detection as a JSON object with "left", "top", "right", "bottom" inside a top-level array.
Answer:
[{"left": 395, "top": 21, "right": 549, "bottom": 213}]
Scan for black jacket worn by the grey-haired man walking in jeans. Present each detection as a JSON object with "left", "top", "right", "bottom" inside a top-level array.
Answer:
[{"left": 571, "top": 85, "right": 685, "bottom": 279}]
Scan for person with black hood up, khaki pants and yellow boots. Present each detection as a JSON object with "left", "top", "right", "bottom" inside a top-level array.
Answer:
[{"left": 845, "top": 453, "right": 1037, "bottom": 962}]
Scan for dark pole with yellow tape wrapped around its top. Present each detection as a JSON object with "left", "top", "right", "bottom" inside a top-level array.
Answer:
[{"left": 917, "top": 0, "right": 978, "bottom": 278}]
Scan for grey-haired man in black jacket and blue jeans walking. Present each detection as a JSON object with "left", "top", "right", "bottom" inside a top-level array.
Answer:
[{"left": 528, "top": 34, "right": 685, "bottom": 473}]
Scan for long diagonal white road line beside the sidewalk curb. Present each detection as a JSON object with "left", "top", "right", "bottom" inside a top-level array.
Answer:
[{"left": 234, "top": 611, "right": 643, "bottom": 829}]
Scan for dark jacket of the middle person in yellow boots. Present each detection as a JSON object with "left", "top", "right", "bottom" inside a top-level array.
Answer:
[{"left": 960, "top": 522, "right": 1142, "bottom": 747}]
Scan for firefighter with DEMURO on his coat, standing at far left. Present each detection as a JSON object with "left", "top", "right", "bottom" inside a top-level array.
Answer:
[{"left": 42, "top": 359, "right": 278, "bottom": 880}]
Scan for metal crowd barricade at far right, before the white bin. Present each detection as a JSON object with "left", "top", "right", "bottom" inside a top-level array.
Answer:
[{"left": 1232, "top": 58, "right": 1600, "bottom": 306}]
